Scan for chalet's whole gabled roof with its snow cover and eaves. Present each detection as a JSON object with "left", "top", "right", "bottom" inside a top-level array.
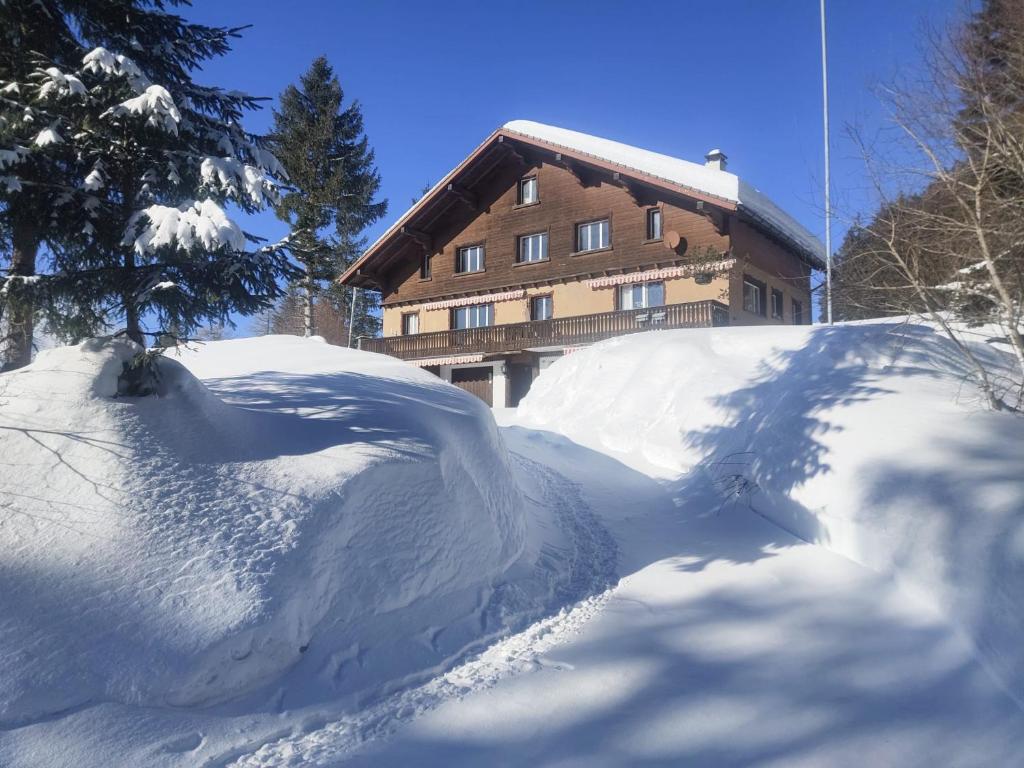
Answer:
[{"left": 340, "top": 120, "right": 824, "bottom": 285}]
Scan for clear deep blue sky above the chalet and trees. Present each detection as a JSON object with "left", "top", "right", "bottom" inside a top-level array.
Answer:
[{"left": 186, "top": 0, "right": 964, "bottom": 327}]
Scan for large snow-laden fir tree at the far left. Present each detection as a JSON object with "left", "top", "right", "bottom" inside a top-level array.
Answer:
[{"left": 0, "top": 0, "right": 296, "bottom": 372}]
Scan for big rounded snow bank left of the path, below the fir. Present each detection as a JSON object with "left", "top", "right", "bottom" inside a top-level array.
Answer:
[{"left": 0, "top": 337, "right": 528, "bottom": 728}]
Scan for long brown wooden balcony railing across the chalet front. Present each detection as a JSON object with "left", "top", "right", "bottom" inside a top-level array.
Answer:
[{"left": 359, "top": 300, "right": 729, "bottom": 360}]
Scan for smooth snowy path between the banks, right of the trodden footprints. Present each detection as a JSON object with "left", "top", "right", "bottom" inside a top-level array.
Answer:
[{"left": 331, "top": 423, "right": 1024, "bottom": 768}]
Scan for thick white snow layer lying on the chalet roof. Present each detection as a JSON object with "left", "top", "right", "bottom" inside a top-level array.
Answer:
[{"left": 504, "top": 120, "right": 824, "bottom": 260}]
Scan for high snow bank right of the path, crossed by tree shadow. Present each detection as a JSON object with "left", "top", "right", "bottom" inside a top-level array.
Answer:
[{"left": 519, "top": 322, "right": 1024, "bottom": 701}]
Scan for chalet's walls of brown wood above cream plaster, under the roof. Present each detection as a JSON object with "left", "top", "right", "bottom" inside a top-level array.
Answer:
[{"left": 342, "top": 123, "right": 814, "bottom": 406}]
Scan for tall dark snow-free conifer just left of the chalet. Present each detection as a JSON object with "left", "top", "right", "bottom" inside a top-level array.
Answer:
[{"left": 271, "top": 56, "right": 387, "bottom": 338}]
